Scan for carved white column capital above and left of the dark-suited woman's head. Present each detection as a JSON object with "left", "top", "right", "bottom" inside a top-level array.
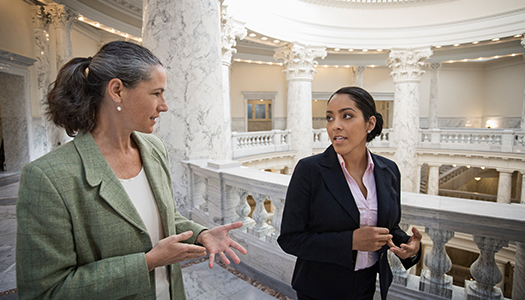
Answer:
[{"left": 273, "top": 43, "right": 327, "bottom": 81}]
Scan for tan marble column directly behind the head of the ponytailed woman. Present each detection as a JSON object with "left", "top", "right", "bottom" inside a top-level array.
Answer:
[{"left": 45, "top": 4, "right": 78, "bottom": 149}]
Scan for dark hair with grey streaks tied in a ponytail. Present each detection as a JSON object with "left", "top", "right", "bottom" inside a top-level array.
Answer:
[{"left": 46, "top": 41, "right": 162, "bottom": 136}]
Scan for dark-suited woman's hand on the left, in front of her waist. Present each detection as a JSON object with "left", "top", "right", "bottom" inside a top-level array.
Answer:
[{"left": 352, "top": 226, "right": 392, "bottom": 252}]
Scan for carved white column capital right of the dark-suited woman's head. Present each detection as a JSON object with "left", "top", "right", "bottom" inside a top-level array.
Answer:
[{"left": 386, "top": 47, "right": 432, "bottom": 83}]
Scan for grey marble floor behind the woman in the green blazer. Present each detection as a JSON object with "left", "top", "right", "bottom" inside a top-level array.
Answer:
[{"left": 0, "top": 172, "right": 289, "bottom": 300}]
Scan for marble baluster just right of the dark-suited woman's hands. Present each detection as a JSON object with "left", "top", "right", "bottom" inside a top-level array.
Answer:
[{"left": 419, "top": 228, "right": 454, "bottom": 299}]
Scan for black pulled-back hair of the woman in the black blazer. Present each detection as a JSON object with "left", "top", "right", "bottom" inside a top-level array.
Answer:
[{"left": 328, "top": 86, "right": 383, "bottom": 142}]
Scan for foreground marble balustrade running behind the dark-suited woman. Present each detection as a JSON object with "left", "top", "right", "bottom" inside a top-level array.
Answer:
[{"left": 183, "top": 160, "right": 525, "bottom": 299}]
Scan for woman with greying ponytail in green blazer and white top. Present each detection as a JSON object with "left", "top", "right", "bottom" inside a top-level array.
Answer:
[{"left": 16, "top": 42, "right": 246, "bottom": 299}]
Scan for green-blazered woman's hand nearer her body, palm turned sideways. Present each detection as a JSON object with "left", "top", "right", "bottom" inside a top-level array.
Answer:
[{"left": 146, "top": 231, "right": 206, "bottom": 271}]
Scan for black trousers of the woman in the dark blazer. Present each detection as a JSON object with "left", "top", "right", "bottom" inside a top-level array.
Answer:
[{"left": 297, "top": 263, "right": 379, "bottom": 300}]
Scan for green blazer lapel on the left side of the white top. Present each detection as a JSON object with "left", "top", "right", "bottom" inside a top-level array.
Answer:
[{"left": 74, "top": 133, "right": 146, "bottom": 232}]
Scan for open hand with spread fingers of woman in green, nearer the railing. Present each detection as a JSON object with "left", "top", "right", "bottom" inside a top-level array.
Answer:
[{"left": 197, "top": 222, "right": 248, "bottom": 269}]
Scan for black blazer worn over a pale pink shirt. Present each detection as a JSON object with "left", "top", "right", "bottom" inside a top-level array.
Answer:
[{"left": 278, "top": 146, "right": 421, "bottom": 299}]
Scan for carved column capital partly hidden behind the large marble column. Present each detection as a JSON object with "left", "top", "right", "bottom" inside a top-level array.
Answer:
[{"left": 221, "top": 5, "right": 248, "bottom": 66}]
